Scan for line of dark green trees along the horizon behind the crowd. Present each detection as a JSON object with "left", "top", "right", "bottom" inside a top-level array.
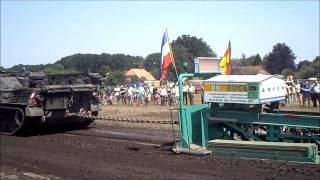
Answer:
[{"left": 0, "top": 35, "right": 320, "bottom": 85}]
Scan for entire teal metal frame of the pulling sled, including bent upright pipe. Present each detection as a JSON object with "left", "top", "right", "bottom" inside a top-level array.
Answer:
[{"left": 176, "top": 73, "right": 320, "bottom": 163}]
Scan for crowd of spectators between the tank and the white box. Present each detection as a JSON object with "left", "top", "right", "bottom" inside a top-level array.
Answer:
[{"left": 103, "top": 81, "right": 203, "bottom": 106}]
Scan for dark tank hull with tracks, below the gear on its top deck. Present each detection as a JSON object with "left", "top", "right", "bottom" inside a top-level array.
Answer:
[{"left": 0, "top": 74, "right": 102, "bottom": 135}]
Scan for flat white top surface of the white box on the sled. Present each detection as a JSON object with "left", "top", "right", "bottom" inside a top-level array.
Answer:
[{"left": 205, "top": 75, "right": 277, "bottom": 83}]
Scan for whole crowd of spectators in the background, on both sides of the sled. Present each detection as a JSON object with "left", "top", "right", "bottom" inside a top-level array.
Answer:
[{"left": 103, "top": 76, "right": 320, "bottom": 107}]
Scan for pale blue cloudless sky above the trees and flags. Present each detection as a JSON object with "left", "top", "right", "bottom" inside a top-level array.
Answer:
[{"left": 0, "top": 0, "right": 320, "bottom": 68}]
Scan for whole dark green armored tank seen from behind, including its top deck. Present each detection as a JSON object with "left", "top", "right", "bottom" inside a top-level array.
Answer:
[{"left": 0, "top": 73, "right": 102, "bottom": 135}]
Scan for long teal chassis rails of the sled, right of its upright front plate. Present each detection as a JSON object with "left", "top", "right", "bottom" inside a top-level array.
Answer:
[{"left": 209, "top": 110, "right": 320, "bottom": 146}]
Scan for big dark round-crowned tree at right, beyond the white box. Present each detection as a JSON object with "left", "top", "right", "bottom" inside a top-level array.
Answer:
[{"left": 263, "top": 43, "right": 296, "bottom": 74}]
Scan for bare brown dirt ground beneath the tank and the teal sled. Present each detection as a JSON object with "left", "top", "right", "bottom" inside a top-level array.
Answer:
[{"left": 0, "top": 106, "right": 320, "bottom": 179}]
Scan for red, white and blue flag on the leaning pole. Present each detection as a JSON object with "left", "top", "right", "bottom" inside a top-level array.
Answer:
[{"left": 160, "top": 32, "right": 173, "bottom": 80}]
